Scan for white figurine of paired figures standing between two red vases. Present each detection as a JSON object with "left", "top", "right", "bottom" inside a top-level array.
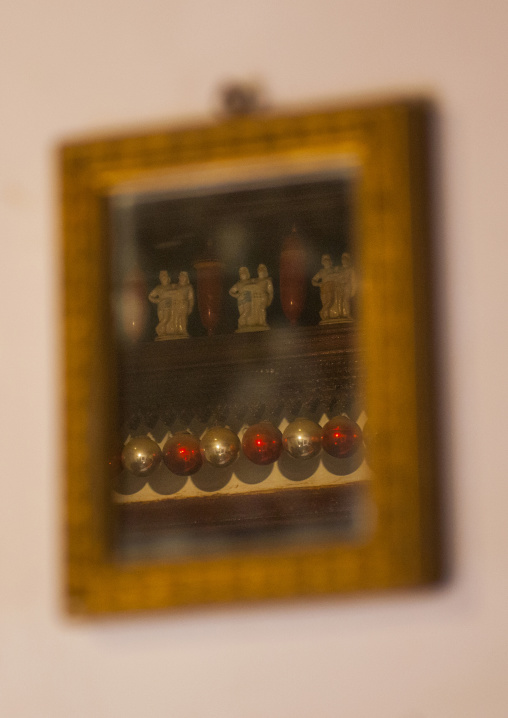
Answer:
[{"left": 229, "top": 264, "right": 273, "bottom": 332}]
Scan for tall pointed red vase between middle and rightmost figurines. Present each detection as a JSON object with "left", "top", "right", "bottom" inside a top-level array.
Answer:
[{"left": 279, "top": 227, "right": 307, "bottom": 324}]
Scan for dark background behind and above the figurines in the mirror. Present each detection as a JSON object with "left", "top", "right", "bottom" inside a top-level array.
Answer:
[{"left": 112, "top": 174, "right": 355, "bottom": 340}]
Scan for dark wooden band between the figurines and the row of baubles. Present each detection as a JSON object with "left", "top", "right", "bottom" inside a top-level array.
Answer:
[{"left": 118, "top": 324, "right": 362, "bottom": 427}]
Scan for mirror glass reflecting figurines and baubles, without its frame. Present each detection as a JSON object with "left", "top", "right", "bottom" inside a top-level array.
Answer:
[{"left": 109, "top": 163, "right": 372, "bottom": 560}]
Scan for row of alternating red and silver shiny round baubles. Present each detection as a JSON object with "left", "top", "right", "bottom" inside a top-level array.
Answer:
[{"left": 121, "top": 416, "right": 362, "bottom": 476}]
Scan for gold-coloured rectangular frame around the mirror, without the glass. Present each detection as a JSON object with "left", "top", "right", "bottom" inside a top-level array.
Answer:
[{"left": 60, "top": 102, "right": 442, "bottom": 614}]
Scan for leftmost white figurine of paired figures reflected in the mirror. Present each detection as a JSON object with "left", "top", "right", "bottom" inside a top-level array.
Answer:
[{"left": 148, "top": 270, "right": 194, "bottom": 341}]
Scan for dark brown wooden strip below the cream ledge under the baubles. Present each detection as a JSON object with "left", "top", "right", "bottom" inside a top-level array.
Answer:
[{"left": 116, "top": 483, "right": 368, "bottom": 556}]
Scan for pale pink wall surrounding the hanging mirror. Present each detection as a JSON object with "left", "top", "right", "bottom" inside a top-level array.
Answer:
[{"left": 0, "top": 0, "right": 508, "bottom": 718}]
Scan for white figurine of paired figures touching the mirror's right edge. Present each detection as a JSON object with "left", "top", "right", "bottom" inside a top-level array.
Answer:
[{"left": 312, "top": 252, "right": 356, "bottom": 324}]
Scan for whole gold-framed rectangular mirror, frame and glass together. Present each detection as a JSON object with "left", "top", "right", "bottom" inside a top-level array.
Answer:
[{"left": 60, "top": 102, "right": 441, "bottom": 614}]
